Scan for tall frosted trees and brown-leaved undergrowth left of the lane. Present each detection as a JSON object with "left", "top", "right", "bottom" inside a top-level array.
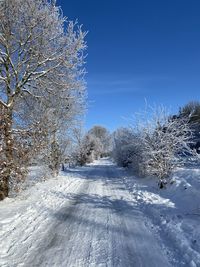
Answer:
[{"left": 0, "top": 0, "right": 86, "bottom": 199}]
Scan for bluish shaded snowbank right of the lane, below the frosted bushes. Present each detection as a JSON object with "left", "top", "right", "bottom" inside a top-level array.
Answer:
[{"left": 124, "top": 168, "right": 200, "bottom": 267}]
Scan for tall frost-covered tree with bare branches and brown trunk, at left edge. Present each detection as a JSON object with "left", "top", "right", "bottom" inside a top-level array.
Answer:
[{"left": 0, "top": 0, "right": 85, "bottom": 200}]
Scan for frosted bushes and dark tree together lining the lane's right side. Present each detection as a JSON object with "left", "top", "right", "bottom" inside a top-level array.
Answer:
[{"left": 113, "top": 102, "right": 200, "bottom": 188}]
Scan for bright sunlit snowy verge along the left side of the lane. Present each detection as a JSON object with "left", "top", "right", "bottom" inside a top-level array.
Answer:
[{"left": 0, "top": 170, "right": 85, "bottom": 267}]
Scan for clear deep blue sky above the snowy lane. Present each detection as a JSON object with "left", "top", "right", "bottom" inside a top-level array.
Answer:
[{"left": 57, "top": 0, "right": 200, "bottom": 130}]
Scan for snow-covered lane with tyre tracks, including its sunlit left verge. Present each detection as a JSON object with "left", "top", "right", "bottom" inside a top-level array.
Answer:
[{"left": 0, "top": 160, "right": 172, "bottom": 267}]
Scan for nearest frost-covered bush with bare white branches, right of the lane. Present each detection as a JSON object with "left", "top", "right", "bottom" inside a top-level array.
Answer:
[{"left": 141, "top": 113, "right": 192, "bottom": 186}]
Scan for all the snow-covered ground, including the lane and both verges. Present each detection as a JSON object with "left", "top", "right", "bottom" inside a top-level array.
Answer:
[{"left": 0, "top": 159, "right": 200, "bottom": 267}]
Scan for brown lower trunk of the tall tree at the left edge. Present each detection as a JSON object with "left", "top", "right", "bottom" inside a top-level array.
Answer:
[{"left": 0, "top": 109, "right": 13, "bottom": 200}]
